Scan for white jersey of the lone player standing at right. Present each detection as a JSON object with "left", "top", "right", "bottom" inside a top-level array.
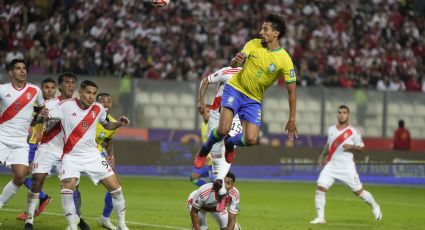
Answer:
[{"left": 327, "top": 125, "right": 364, "bottom": 164}]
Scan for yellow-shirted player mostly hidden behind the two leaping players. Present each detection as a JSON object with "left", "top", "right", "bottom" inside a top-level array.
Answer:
[{"left": 190, "top": 105, "right": 214, "bottom": 187}]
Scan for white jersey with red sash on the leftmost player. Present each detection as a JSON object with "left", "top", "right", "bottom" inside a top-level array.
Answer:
[{"left": 0, "top": 83, "right": 44, "bottom": 145}]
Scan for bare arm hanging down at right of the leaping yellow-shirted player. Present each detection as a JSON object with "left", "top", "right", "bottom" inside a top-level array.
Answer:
[{"left": 285, "top": 82, "right": 298, "bottom": 141}]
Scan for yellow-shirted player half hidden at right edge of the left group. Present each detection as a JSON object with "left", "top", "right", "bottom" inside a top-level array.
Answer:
[{"left": 96, "top": 93, "right": 118, "bottom": 229}]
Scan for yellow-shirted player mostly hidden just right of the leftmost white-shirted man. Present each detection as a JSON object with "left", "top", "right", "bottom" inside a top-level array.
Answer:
[{"left": 17, "top": 78, "right": 56, "bottom": 220}]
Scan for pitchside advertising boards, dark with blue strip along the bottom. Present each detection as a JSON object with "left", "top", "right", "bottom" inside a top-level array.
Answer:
[{"left": 115, "top": 141, "right": 425, "bottom": 185}]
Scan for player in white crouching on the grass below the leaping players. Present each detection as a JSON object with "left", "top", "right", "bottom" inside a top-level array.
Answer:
[{"left": 188, "top": 172, "right": 240, "bottom": 230}]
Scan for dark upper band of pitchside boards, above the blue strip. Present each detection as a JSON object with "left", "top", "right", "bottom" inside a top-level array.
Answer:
[{"left": 114, "top": 141, "right": 425, "bottom": 165}]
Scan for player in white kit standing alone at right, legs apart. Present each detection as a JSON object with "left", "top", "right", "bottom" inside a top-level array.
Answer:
[{"left": 310, "top": 105, "right": 382, "bottom": 224}]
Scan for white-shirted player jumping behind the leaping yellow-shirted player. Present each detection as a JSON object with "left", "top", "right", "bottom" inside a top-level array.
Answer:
[{"left": 198, "top": 67, "right": 242, "bottom": 208}]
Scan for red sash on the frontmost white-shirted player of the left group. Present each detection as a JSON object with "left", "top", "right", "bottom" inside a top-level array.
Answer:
[{"left": 62, "top": 105, "right": 100, "bottom": 156}]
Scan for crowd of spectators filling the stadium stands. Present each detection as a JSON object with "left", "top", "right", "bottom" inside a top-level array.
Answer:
[{"left": 0, "top": 0, "right": 425, "bottom": 91}]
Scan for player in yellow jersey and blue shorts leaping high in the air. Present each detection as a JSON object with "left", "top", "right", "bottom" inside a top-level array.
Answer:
[{"left": 194, "top": 13, "right": 298, "bottom": 168}]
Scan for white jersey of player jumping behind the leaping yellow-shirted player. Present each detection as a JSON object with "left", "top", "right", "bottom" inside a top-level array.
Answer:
[{"left": 207, "top": 67, "right": 242, "bottom": 117}]
